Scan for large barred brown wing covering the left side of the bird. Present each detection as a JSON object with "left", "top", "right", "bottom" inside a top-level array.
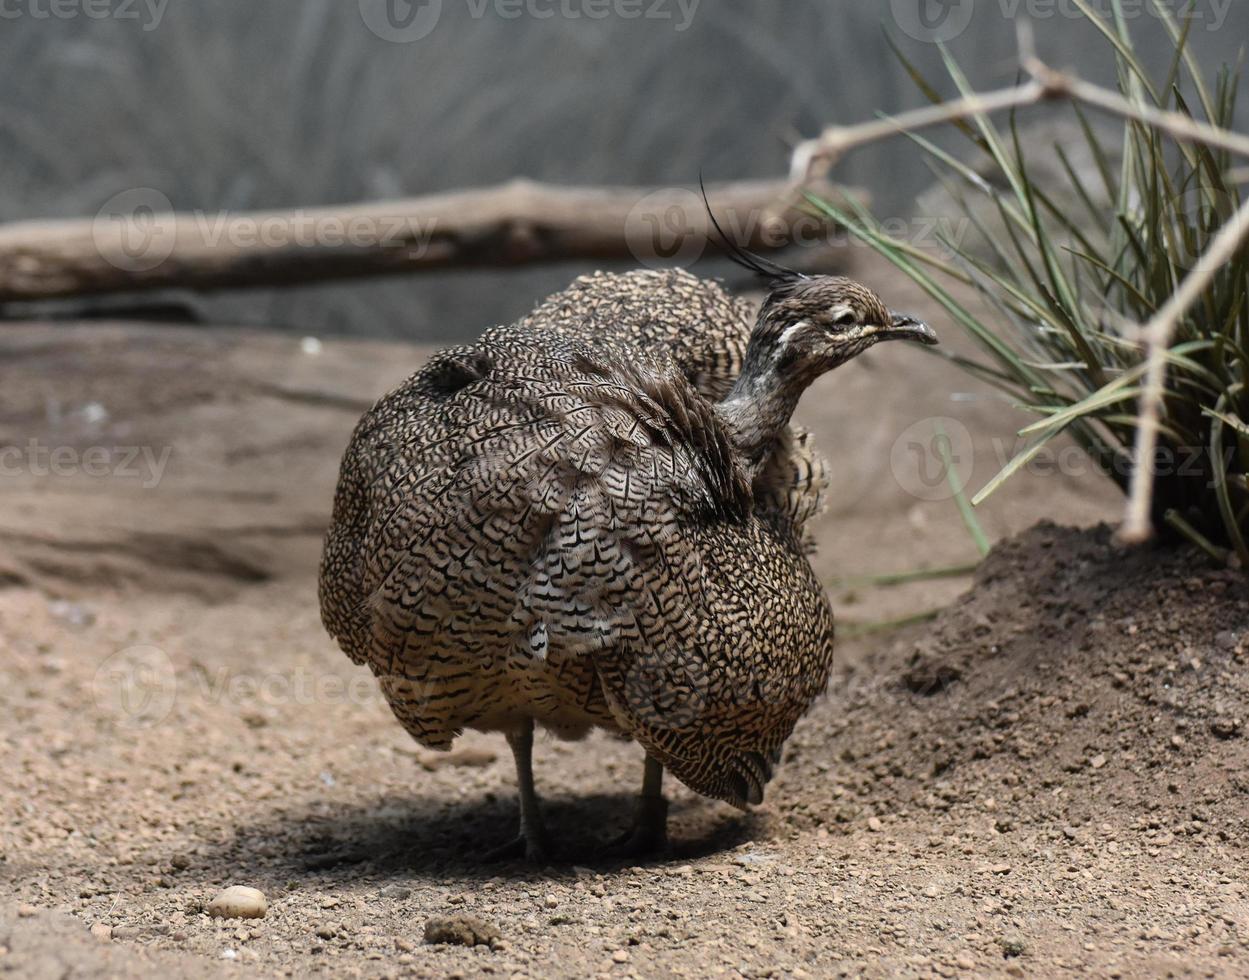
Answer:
[{"left": 321, "top": 327, "right": 749, "bottom": 674}]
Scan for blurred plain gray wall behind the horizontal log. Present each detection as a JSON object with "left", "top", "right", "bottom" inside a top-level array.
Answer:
[{"left": 0, "top": 0, "right": 1249, "bottom": 340}]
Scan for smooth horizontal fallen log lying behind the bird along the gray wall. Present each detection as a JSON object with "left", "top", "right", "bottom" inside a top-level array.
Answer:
[{"left": 0, "top": 180, "right": 866, "bottom": 302}]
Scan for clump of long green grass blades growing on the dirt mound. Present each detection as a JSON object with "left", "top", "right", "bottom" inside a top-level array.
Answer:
[{"left": 817, "top": 2, "right": 1249, "bottom": 567}]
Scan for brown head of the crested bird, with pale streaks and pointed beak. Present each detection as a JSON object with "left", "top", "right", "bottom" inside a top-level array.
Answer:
[{"left": 754, "top": 273, "right": 937, "bottom": 375}]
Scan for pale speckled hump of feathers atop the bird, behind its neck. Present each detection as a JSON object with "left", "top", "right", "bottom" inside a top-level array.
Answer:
[{"left": 520, "top": 270, "right": 754, "bottom": 402}]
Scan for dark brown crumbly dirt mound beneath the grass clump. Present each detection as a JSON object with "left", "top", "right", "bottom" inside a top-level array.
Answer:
[{"left": 783, "top": 523, "right": 1249, "bottom": 841}]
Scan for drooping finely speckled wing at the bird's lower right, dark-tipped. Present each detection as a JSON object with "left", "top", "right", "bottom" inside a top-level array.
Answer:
[{"left": 596, "top": 518, "right": 833, "bottom": 806}]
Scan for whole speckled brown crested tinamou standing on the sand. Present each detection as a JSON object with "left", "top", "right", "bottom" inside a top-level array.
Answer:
[{"left": 320, "top": 250, "right": 937, "bottom": 860}]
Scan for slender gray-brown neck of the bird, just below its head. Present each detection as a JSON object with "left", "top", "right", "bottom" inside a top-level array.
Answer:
[{"left": 716, "top": 331, "right": 818, "bottom": 476}]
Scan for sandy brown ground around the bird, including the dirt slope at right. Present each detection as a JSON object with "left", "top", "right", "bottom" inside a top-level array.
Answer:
[{"left": 0, "top": 255, "right": 1249, "bottom": 978}]
